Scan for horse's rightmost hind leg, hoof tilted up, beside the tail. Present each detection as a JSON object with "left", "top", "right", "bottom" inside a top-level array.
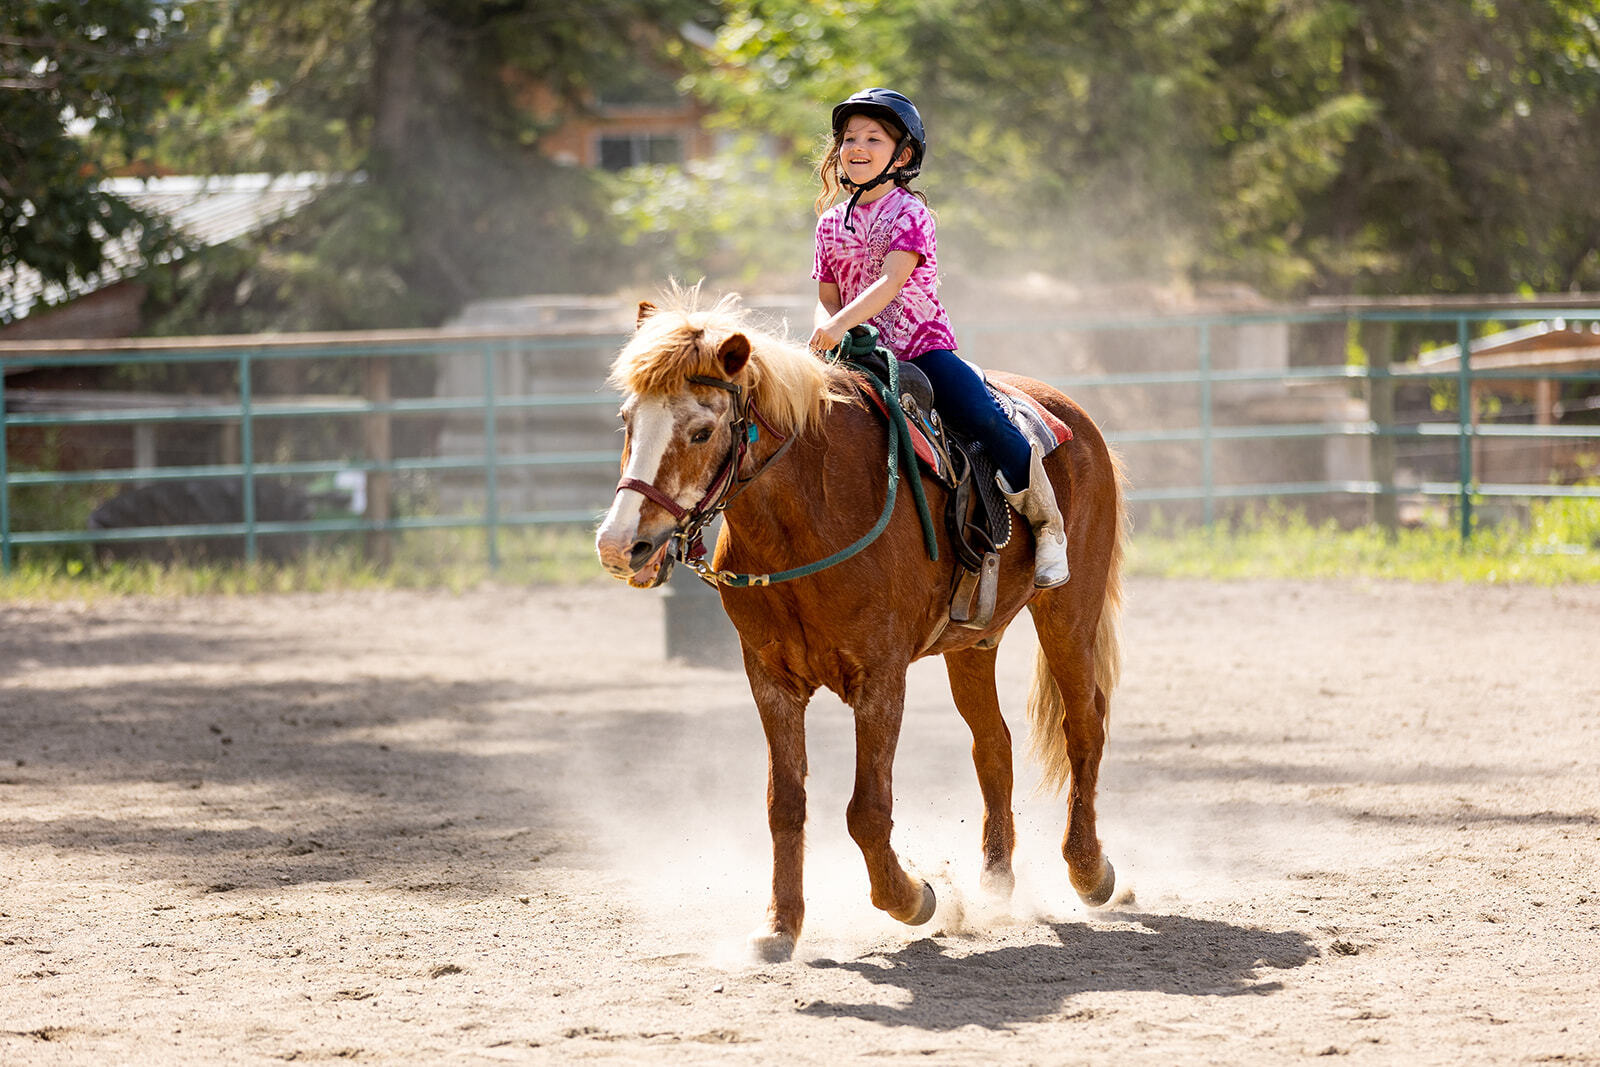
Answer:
[{"left": 1030, "top": 589, "right": 1117, "bottom": 907}]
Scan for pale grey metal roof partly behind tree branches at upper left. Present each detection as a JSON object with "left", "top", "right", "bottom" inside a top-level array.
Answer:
[{"left": 0, "top": 173, "right": 336, "bottom": 320}]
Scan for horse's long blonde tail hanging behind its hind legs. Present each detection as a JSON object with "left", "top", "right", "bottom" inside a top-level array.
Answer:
[{"left": 1027, "top": 456, "right": 1128, "bottom": 793}]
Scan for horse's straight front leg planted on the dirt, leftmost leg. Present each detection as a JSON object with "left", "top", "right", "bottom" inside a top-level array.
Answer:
[{"left": 744, "top": 651, "right": 811, "bottom": 963}]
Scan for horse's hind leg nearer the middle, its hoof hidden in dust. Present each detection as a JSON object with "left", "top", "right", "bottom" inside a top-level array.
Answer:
[{"left": 944, "top": 648, "right": 1016, "bottom": 896}]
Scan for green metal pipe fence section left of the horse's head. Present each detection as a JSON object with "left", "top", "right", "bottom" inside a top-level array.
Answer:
[{"left": 0, "top": 331, "right": 624, "bottom": 571}]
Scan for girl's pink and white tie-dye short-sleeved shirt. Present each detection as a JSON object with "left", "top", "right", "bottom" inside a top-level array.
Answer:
[{"left": 811, "top": 186, "right": 955, "bottom": 360}]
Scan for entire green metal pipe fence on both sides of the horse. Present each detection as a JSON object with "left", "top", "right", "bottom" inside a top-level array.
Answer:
[{"left": 0, "top": 307, "right": 1600, "bottom": 571}]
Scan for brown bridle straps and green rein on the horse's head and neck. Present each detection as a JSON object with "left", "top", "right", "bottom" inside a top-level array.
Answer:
[{"left": 616, "top": 326, "right": 939, "bottom": 589}]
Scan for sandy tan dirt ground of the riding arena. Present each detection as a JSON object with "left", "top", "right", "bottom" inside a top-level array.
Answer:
[{"left": 0, "top": 581, "right": 1600, "bottom": 1067}]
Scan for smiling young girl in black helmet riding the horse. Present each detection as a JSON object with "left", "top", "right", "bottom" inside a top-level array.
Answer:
[{"left": 811, "top": 88, "right": 1069, "bottom": 589}]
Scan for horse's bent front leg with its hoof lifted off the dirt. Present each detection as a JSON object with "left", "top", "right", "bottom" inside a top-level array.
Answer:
[{"left": 845, "top": 670, "right": 934, "bottom": 926}]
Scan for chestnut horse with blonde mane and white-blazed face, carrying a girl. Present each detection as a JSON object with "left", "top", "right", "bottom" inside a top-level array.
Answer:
[{"left": 595, "top": 290, "right": 1125, "bottom": 960}]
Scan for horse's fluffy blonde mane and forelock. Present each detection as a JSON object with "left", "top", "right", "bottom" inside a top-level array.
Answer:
[{"left": 610, "top": 285, "right": 854, "bottom": 437}]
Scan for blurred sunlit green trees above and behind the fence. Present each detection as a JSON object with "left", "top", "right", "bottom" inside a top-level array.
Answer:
[{"left": 0, "top": 0, "right": 1600, "bottom": 333}]
